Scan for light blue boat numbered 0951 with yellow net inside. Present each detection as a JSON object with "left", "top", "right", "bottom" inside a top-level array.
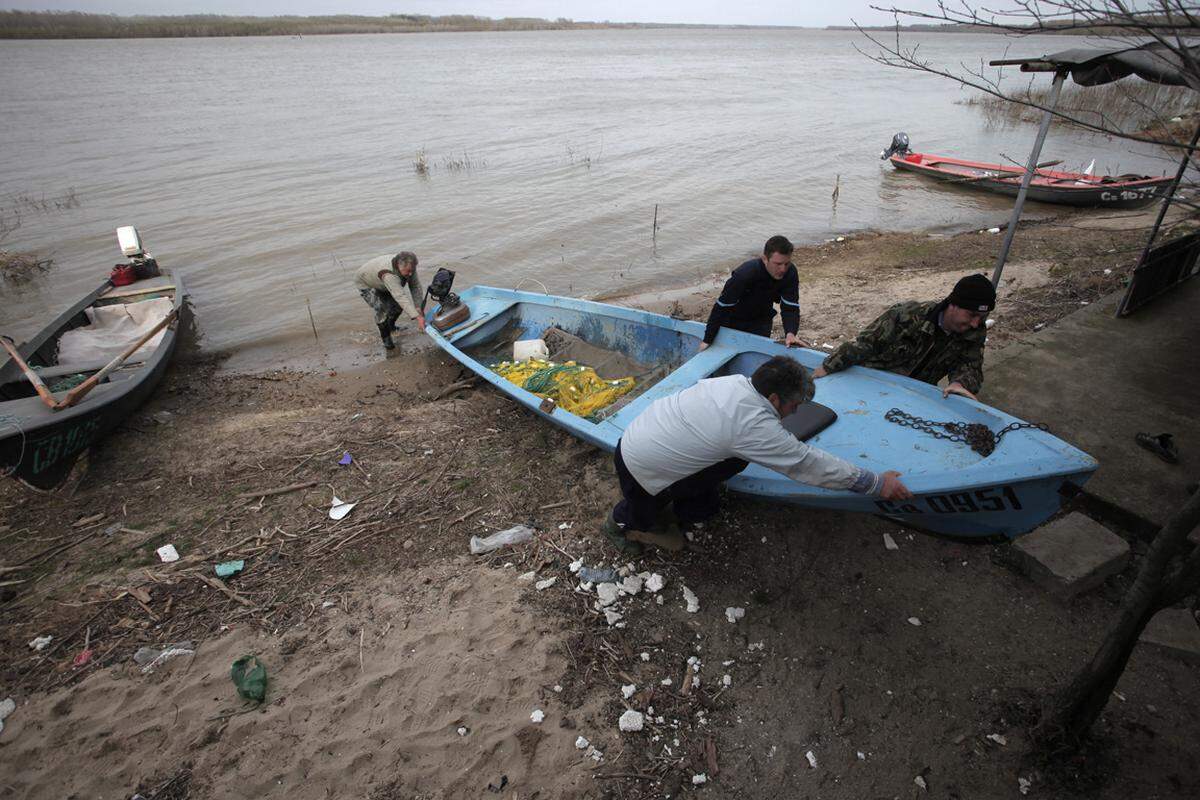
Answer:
[{"left": 426, "top": 285, "right": 1098, "bottom": 539}]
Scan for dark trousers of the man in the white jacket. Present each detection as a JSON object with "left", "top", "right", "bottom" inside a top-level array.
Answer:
[{"left": 612, "top": 441, "right": 749, "bottom": 530}]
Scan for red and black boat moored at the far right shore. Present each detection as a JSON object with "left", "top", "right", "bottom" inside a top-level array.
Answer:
[{"left": 888, "top": 152, "right": 1172, "bottom": 209}]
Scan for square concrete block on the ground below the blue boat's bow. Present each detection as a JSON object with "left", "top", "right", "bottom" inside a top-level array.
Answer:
[{"left": 1013, "top": 511, "right": 1129, "bottom": 599}]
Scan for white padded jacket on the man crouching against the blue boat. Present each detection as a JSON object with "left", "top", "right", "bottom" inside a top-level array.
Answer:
[{"left": 620, "top": 375, "right": 883, "bottom": 494}]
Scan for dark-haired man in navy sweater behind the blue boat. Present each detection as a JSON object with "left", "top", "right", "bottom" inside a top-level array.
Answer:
[{"left": 700, "top": 236, "right": 806, "bottom": 350}]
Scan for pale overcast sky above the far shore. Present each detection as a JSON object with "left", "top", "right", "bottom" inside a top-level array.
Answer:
[{"left": 0, "top": 0, "right": 955, "bottom": 28}]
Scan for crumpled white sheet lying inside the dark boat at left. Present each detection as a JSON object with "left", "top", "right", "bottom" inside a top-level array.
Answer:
[{"left": 59, "top": 297, "right": 175, "bottom": 366}]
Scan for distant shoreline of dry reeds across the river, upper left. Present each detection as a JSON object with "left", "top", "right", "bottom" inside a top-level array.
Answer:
[{"left": 0, "top": 11, "right": 820, "bottom": 40}]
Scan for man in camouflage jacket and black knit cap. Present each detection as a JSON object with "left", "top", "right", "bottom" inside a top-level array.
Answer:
[{"left": 812, "top": 275, "right": 996, "bottom": 399}]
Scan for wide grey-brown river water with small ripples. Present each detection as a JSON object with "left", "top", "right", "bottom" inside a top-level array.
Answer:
[{"left": 0, "top": 29, "right": 1169, "bottom": 362}]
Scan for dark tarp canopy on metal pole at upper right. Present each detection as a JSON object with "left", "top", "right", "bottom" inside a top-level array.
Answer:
[{"left": 990, "top": 42, "right": 1200, "bottom": 91}]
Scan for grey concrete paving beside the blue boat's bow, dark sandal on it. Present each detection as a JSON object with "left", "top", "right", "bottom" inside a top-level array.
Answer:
[{"left": 980, "top": 278, "right": 1200, "bottom": 525}]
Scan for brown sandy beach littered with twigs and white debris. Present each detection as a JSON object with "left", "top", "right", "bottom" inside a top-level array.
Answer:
[{"left": 0, "top": 215, "right": 1200, "bottom": 800}]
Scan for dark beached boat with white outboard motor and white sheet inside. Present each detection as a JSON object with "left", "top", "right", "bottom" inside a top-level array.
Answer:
[{"left": 0, "top": 237, "right": 186, "bottom": 489}]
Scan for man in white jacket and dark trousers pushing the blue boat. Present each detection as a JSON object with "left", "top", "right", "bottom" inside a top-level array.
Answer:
[{"left": 604, "top": 355, "right": 912, "bottom": 555}]
